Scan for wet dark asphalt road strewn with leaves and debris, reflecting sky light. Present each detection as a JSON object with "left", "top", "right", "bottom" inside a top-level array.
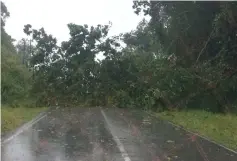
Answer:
[{"left": 1, "top": 108, "right": 237, "bottom": 161}]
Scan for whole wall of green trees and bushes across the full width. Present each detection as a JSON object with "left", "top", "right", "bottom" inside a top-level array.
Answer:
[{"left": 2, "top": 1, "right": 237, "bottom": 112}]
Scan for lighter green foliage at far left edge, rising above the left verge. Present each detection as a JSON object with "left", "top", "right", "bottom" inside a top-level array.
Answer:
[{"left": 1, "top": 2, "right": 31, "bottom": 107}]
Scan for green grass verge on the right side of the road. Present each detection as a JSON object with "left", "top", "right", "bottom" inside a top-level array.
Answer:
[{"left": 157, "top": 110, "right": 237, "bottom": 151}]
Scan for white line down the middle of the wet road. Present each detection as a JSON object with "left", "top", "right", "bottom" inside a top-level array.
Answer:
[{"left": 101, "top": 109, "right": 131, "bottom": 161}]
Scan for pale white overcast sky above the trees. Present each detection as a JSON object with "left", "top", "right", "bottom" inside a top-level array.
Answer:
[{"left": 3, "top": 0, "right": 142, "bottom": 42}]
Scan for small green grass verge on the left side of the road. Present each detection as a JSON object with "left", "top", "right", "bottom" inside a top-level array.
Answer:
[{"left": 1, "top": 107, "right": 46, "bottom": 134}]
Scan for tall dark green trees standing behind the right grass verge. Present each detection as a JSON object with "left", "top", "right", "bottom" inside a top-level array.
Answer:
[{"left": 130, "top": 1, "right": 237, "bottom": 112}]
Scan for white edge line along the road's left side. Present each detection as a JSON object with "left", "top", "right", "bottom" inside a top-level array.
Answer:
[{"left": 2, "top": 114, "right": 47, "bottom": 144}]
